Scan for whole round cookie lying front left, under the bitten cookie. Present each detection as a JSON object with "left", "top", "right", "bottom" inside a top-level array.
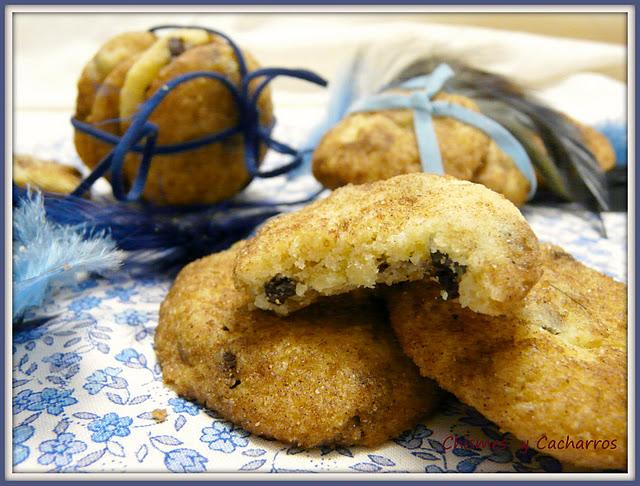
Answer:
[{"left": 155, "top": 243, "right": 439, "bottom": 447}]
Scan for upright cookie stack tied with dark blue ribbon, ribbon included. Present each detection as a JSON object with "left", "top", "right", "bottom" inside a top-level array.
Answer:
[{"left": 72, "top": 26, "right": 326, "bottom": 206}]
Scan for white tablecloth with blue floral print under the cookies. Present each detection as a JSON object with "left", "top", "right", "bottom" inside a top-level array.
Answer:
[{"left": 13, "top": 192, "right": 626, "bottom": 472}]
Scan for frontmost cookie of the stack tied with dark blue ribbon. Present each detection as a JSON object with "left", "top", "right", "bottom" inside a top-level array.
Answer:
[{"left": 123, "top": 40, "right": 273, "bottom": 204}]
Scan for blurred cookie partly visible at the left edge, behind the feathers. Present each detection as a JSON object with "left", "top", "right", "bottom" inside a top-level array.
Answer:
[{"left": 13, "top": 155, "right": 82, "bottom": 194}]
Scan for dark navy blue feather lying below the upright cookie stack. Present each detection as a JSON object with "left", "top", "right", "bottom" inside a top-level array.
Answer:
[{"left": 13, "top": 186, "right": 290, "bottom": 273}]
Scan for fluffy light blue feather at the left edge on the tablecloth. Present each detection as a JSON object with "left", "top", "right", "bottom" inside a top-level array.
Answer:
[{"left": 13, "top": 192, "right": 123, "bottom": 321}]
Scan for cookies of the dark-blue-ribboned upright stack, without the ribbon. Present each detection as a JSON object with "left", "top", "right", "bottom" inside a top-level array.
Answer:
[{"left": 75, "top": 29, "right": 273, "bottom": 205}]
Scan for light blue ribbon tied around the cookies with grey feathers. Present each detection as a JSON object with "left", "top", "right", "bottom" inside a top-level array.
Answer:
[{"left": 349, "top": 64, "right": 538, "bottom": 199}]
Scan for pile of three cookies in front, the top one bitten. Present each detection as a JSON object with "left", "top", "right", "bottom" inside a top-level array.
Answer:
[{"left": 156, "top": 173, "right": 627, "bottom": 469}]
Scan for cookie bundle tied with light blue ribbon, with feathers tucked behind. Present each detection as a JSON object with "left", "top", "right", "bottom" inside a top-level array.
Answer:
[{"left": 309, "top": 57, "right": 615, "bottom": 211}]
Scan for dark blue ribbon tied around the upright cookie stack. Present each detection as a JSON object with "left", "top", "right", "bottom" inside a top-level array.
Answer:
[{"left": 71, "top": 25, "right": 327, "bottom": 201}]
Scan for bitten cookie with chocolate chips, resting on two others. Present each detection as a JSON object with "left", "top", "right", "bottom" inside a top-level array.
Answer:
[{"left": 235, "top": 173, "right": 541, "bottom": 315}]
